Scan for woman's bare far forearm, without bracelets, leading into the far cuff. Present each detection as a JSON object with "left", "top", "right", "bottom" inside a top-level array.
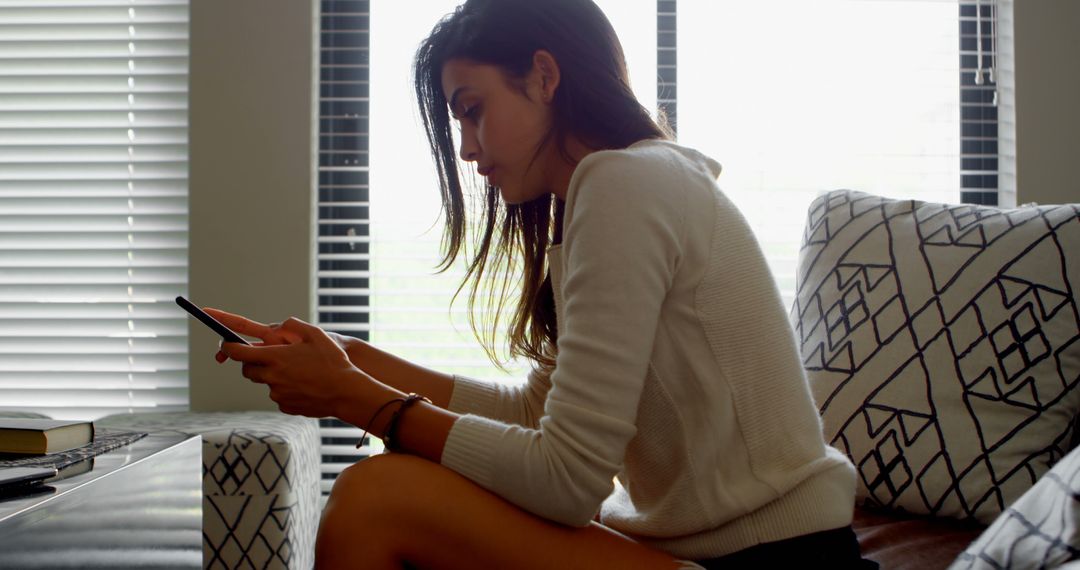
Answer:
[{"left": 339, "top": 336, "right": 454, "bottom": 408}]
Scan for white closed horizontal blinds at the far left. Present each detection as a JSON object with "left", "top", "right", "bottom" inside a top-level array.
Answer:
[{"left": 0, "top": 0, "right": 188, "bottom": 419}]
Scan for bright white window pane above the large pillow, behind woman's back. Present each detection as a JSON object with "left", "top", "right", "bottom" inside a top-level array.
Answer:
[{"left": 677, "top": 0, "right": 960, "bottom": 303}]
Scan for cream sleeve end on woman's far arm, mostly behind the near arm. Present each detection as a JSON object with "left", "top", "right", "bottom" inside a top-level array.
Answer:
[{"left": 448, "top": 369, "right": 551, "bottom": 429}]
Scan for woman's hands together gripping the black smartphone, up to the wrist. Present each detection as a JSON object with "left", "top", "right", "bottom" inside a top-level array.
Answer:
[{"left": 217, "top": 311, "right": 375, "bottom": 418}]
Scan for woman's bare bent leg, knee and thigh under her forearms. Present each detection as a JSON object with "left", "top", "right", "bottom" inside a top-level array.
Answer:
[{"left": 315, "top": 454, "right": 678, "bottom": 570}]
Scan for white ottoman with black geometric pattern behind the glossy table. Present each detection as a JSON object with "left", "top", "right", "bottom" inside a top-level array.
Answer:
[{"left": 95, "top": 411, "right": 322, "bottom": 570}]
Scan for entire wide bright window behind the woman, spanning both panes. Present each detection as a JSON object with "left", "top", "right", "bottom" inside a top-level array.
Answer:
[{"left": 319, "top": 0, "right": 1006, "bottom": 490}]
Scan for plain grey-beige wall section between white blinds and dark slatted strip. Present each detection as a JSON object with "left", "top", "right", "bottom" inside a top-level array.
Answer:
[{"left": 189, "top": 0, "right": 319, "bottom": 411}]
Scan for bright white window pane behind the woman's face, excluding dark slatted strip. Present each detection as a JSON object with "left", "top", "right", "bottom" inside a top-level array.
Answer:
[{"left": 362, "top": 0, "right": 657, "bottom": 378}]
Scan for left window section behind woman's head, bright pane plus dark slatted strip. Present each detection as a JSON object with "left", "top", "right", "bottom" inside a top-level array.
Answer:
[{"left": 318, "top": 0, "right": 657, "bottom": 492}]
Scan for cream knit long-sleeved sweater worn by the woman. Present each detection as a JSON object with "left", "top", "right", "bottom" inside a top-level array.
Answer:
[{"left": 443, "top": 141, "right": 855, "bottom": 558}]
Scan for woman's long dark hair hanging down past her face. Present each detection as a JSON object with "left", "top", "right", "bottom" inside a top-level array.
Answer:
[{"left": 414, "top": 0, "right": 670, "bottom": 367}]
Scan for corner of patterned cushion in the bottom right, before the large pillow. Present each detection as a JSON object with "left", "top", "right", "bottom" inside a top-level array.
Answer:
[{"left": 949, "top": 442, "right": 1080, "bottom": 570}]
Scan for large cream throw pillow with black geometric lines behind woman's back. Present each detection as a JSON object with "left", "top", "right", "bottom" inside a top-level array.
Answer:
[{"left": 792, "top": 190, "right": 1080, "bottom": 524}]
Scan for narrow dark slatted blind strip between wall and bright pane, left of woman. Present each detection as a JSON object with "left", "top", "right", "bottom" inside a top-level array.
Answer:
[{"left": 316, "top": 0, "right": 378, "bottom": 494}]
